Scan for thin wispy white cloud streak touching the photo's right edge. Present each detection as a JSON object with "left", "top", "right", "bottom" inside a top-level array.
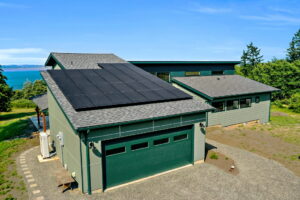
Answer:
[{"left": 241, "top": 15, "right": 300, "bottom": 25}]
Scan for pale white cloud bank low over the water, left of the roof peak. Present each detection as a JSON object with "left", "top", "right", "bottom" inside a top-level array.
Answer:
[{"left": 0, "top": 48, "right": 48, "bottom": 65}]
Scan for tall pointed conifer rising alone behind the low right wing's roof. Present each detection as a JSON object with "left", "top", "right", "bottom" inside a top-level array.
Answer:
[{"left": 241, "top": 42, "right": 263, "bottom": 76}]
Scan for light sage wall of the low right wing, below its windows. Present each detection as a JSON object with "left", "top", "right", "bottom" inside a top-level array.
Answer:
[{"left": 208, "top": 93, "right": 270, "bottom": 126}]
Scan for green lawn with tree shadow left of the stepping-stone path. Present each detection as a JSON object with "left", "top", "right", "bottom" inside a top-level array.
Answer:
[{"left": 0, "top": 109, "right": 38, "bottom": 199}]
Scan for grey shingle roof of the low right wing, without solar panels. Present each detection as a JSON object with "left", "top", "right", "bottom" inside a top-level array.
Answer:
[{"left": 173, "top": 75, "right": 279, "bottom": 98}]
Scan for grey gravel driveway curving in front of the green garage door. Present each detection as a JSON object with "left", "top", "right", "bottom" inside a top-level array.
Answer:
[{"left": 17, "top": 140, "right": 300, "bottom": 200}]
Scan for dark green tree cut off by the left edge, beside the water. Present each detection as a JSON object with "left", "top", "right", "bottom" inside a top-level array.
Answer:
[{"left": 0, "top": 65, "right": 13, "bottom": 112}]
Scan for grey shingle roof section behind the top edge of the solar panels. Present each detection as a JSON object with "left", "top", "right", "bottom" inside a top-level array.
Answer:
[{"left": 46, "top": 52, "right": 127, "bottom": 69}]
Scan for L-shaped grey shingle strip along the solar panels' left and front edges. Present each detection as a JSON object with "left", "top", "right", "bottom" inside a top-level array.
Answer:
[{"left": 41, "top": 71, "right": 214, "bottom": 129}]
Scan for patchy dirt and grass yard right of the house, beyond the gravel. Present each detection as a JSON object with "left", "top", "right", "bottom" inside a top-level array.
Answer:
[{"left": 207, "top": 106, "right": 300, "bottom": 176}]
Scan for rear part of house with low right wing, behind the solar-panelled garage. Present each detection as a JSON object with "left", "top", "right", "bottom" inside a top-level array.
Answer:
[{"left": 129, "top": 61, "right": 279, "bottom": 126}]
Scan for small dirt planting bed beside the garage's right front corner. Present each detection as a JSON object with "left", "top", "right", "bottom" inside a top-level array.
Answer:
[{"left": 205, "top": 150, "right": 239, "bottom": 175}]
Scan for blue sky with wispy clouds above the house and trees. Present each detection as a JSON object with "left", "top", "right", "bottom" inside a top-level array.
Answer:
[{"left": 0, "top": 0, "right": 300, "bottom": 65}]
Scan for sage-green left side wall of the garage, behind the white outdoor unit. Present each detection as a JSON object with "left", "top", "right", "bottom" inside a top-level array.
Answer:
[{"left": 48, "top": 89, "right": 82, "bottom": 191}]
